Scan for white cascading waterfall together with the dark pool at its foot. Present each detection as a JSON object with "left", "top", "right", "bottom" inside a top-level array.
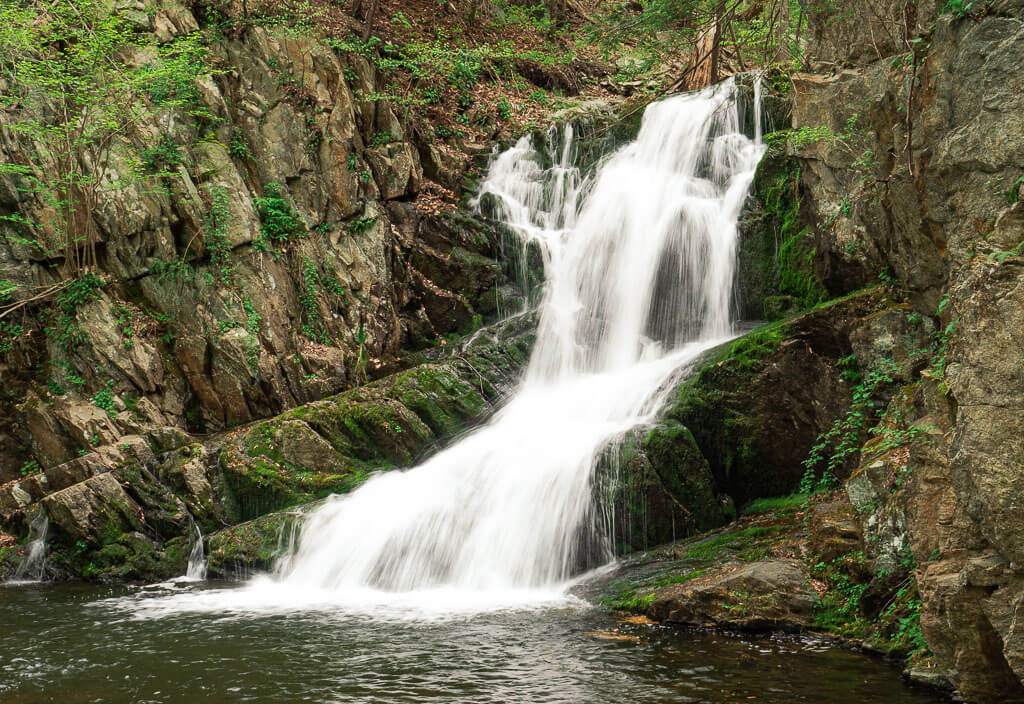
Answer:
[{"left": 0, "top": 82, "right": 946, "bottom": 704}]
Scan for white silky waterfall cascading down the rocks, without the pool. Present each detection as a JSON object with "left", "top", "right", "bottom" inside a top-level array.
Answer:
[{"left": 128, "top": 81, "right": 764, "bottom": 608}]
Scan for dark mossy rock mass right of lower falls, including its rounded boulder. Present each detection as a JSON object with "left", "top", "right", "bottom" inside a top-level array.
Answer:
[{"left": 601, "top": 288, "right": 892, "bottom": 554}]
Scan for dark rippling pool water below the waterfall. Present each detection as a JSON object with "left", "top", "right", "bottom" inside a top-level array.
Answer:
[{"left": 0, "top": 585, "right": 942, "bottom": 704}]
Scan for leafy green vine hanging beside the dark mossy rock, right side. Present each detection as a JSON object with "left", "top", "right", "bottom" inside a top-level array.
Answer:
[{"left": 800, "top": 359, "right": 899, "bottom": 494}]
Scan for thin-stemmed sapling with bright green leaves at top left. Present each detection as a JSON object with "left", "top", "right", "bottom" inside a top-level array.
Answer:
[{"left": 0, "top": 0, "right": 211, "bottom": 277}]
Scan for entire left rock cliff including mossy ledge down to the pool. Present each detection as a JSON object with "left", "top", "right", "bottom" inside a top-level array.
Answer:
[{"left": 0, "top": 2, "right": 544, "bottom": 579}]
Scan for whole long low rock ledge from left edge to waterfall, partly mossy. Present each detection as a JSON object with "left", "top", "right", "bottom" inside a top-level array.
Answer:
[{"left": 0, "top": 316, "right": 534, "bottom": 580}]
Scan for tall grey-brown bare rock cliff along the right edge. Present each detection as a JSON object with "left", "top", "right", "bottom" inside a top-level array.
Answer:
[{"left": 793, "top": 2, "right": 1024, "bottom": 701}]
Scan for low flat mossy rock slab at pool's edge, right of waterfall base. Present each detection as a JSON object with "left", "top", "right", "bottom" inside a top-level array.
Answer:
[{"left": 577, "top": 494, "right": 952, "bottom": 700}]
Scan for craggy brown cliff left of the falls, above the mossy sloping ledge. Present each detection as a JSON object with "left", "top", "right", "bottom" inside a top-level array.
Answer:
[{"left": 0, "top": 15, "right": 521, "bottom": 482}]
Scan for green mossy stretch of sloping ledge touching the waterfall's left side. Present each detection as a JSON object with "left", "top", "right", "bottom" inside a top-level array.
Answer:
[{"left": 202, "top": 313, "right": 532, "bottom": 523}]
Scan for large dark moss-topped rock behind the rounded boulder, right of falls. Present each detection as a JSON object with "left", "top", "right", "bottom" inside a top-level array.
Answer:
[{"left": 662, "top": 289, "right": 885, "bottom": 504}]
